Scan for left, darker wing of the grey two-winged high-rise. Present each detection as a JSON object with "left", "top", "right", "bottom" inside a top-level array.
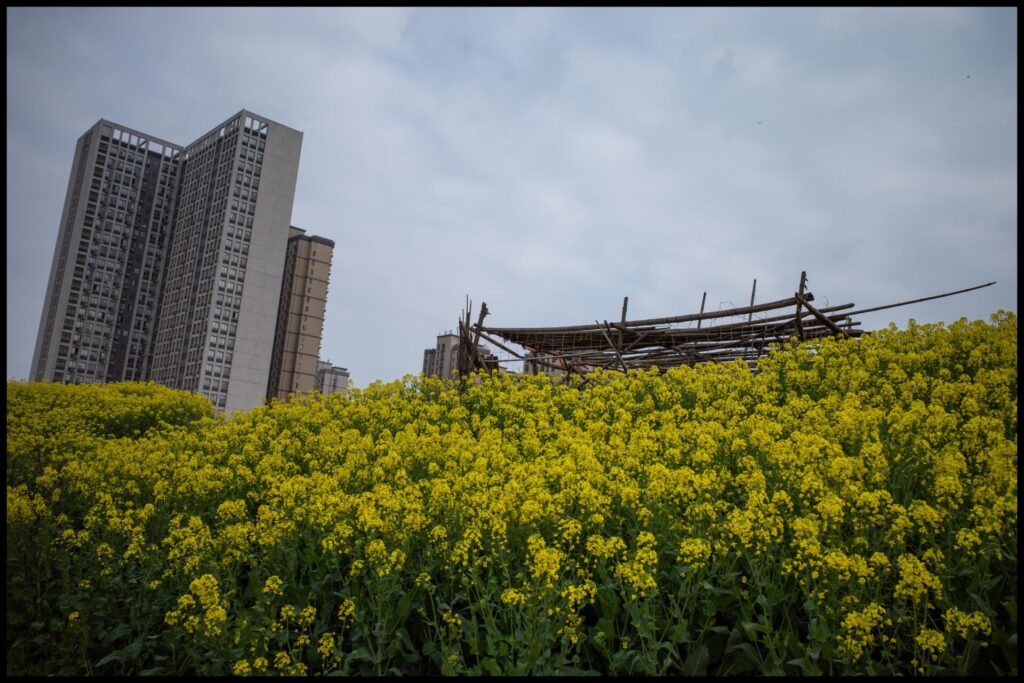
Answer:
[{"left": 30, "top": 120, "right": 182, "bottom": 383}]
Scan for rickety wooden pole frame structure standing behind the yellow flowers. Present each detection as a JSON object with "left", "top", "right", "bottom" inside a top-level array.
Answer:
[{"left": 458, "top": 271, "right": 995, "bottom": 376}]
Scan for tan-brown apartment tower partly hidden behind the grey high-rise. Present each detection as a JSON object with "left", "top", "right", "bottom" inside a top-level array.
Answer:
[{"left": 266, "top": 225, "right": 334, "bottom": 400}]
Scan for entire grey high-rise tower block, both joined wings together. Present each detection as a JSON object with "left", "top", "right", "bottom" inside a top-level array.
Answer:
[{"left": 32, "top": 110, "right": 326, "bottom": 412}]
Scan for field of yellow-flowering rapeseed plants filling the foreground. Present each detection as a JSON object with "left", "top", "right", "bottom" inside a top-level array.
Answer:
[{"left": 6, "top": 311, "right": 1018, "bottom": 676}]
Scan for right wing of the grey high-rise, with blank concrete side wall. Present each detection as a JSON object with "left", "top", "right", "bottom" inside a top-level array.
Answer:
[{"left": 153, "top": 111, "right": 302, "bottom": 412}]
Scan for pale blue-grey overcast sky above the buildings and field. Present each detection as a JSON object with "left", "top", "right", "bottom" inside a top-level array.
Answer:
[{"left": 7, "top": 8, "right": 1018, "bottom": 387}]
